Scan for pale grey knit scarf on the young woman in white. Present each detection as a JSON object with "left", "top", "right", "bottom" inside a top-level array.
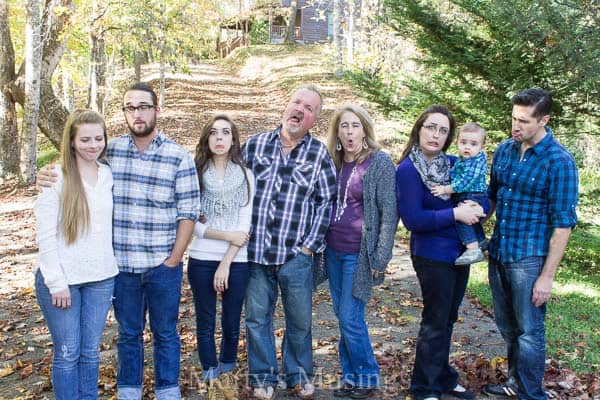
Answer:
[{"left": 200, "top": 161, "right": 248, "bottom": 231}]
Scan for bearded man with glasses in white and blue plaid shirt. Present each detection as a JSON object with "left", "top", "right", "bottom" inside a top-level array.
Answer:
[{"left": 38, "top": 83, "right": 200, "bottom": 400}]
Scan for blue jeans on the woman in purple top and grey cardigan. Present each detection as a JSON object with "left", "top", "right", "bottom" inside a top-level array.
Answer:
[{"left": 326, "top": 247, "right": 379, "bottom": 388}]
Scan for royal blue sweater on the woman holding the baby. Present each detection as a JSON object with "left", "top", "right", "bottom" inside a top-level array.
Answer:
[{"left": 396, "top": 156, "right": 489, "bottom": 264}]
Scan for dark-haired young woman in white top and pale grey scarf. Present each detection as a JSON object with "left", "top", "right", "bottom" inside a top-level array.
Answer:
[{"left": 188, "top": 115, "right": 254, "bottom": 400}]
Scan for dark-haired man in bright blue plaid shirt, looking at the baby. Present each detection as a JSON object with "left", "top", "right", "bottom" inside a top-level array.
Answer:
[{"left": 483, "top": 89, "right": 578, "bottom": 400}]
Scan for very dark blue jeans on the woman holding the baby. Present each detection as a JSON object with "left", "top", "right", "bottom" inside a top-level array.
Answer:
[{"left": 410, "top": 256, "right": 470, "bottom": 399}]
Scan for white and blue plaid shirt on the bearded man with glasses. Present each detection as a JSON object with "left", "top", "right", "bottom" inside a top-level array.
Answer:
[{"left": 107, "top": 132, "right": 200, "bottom": 273}]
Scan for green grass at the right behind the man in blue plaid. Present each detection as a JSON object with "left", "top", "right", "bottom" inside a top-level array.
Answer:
[{"left": 468, "top": 223, "right": 600, "bottom": 372}]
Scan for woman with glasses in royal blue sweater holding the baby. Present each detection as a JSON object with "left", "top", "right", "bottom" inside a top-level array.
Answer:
[{"left": 396, "top": 105, "right": 485, "bottom": 400}]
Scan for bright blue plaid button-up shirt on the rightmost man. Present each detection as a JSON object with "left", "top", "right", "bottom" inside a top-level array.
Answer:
[{"left": 489, "top": 128, "right": 578, "bottom": 263}]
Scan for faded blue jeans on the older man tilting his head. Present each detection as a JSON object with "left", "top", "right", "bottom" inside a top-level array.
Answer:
[{"left": 246, "top": 253, "right": 313, "bottom": 387}]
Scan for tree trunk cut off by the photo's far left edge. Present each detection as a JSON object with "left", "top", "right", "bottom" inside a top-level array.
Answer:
[{"left": 0, "top": 0, "right": 19, "bottom": 180}]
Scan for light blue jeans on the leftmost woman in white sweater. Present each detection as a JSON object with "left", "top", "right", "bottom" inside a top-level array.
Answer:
[{"left": 35, "top": 270, "right": 114, "bottom": 400}]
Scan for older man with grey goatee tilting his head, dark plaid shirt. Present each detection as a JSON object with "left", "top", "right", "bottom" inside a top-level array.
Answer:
[{"left": 243, "top": 85, "right": 336, "bottom": 400}]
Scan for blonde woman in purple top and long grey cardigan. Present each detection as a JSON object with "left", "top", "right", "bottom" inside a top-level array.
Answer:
[{"left": 325, "top": 104, "right": 398, "bottom": 399}]
